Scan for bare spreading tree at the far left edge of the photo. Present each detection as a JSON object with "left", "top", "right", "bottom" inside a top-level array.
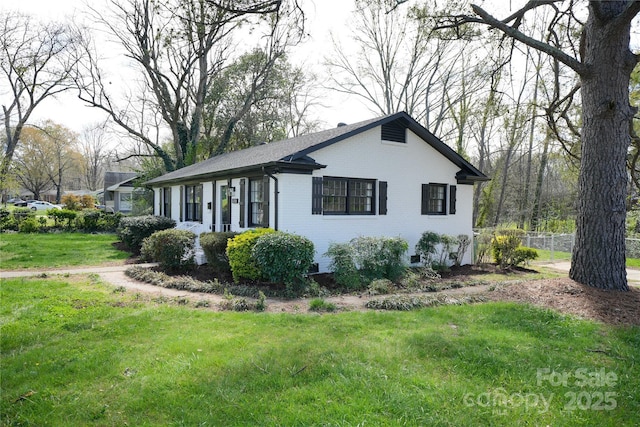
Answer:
[{"left": 0, "top": 11, "right": 80, "bottom": 181}]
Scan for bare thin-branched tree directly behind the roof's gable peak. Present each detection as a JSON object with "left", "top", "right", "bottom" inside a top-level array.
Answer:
[{"left": 325, "top": 0, "right": 461, "bottom": 128}]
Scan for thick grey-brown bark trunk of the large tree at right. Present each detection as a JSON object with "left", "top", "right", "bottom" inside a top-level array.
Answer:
[{"left": 569, "top": 1, "right": 637, "bottom": 290}]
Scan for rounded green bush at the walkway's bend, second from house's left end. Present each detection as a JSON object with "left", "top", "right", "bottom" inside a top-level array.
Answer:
[{"left": 140, "top": 229, "right": 196, "bottom": 271}]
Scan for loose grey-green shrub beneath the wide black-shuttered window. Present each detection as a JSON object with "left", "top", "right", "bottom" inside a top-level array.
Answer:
[{"left": 351, "top": 237, "right": 409, "bottom": 283}]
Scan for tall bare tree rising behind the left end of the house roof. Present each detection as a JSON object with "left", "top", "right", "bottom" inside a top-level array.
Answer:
[{"left": 79, "top": 0, "right": 299, "bottom": 171}]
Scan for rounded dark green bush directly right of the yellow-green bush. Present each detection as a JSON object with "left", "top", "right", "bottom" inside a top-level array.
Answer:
[{"left": 251, "top": 231, "right": 315, "bottom": 288}]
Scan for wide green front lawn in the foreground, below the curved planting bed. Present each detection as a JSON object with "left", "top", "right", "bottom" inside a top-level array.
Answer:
[{"left": 0, "top": 276, "right": 640, "bottom": 426}]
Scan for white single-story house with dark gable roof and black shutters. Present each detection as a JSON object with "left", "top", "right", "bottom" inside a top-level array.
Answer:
[{"left": 147, "top": 113, "right": 488, "bottom": 271}]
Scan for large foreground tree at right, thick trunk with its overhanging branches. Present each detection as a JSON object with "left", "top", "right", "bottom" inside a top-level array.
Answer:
[{"left": 440, "top": 0, "right": 640, "bottom": 290}]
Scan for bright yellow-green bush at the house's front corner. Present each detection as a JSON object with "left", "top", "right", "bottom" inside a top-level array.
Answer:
[{"left": 227, "top": 228, "right": 275, "bottom": 282}]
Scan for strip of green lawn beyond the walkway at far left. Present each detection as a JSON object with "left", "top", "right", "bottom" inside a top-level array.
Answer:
[{"left": 0, "top": 233, "right": 130, "bottom": 270}]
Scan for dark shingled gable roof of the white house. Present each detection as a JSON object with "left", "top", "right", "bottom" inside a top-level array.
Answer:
[{"left": 146, "top": 112, "right": 489, "bottom": 186}]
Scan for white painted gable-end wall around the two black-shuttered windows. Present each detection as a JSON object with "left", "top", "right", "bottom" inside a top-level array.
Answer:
[{"left": 279, "top": 127, "right": 473, "bottom": 271}]
